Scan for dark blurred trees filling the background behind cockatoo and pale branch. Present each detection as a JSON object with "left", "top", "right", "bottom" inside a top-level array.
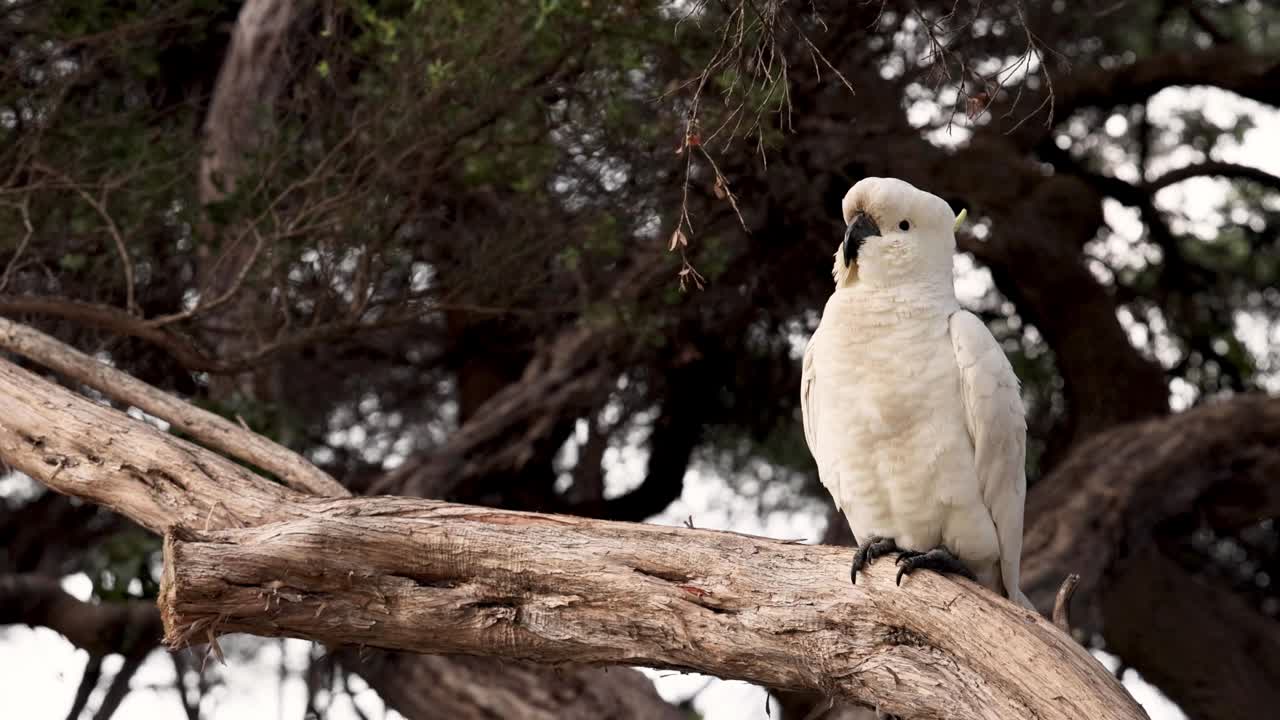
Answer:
[{"left": 0, "top": 0, "right": 1280, "bottom": 720}]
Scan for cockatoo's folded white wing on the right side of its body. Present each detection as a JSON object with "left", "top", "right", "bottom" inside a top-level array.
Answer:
[{"left": 950, "top": 310, "right": 1032, "bottom": 607}]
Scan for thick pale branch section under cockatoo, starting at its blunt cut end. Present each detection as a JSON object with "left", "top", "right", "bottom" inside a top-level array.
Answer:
[{"left": 160, "top": 498, "right": 1143, "bottom": 719}]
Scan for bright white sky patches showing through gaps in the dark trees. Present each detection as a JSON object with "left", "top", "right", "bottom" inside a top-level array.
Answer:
[{"left": 0, "top": 88, "right": 1280, "bottom": 720}]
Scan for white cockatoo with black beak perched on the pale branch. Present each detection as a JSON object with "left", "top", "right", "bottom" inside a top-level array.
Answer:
[{"left": 800, "top": 178, "right": 1032, "bottom": 607}]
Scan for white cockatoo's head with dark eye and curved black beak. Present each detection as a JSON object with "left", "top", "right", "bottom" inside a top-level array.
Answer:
[{"left": 833, "top": 178, "right": 960, "bottom": 288}]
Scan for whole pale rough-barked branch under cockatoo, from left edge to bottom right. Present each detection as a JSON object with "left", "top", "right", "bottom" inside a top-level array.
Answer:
[{"left": 0, "top": 345, "right": 1142, "bottom": 717}]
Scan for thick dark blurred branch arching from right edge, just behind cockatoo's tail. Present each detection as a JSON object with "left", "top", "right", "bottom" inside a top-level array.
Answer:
[{"left": 1023, "top": 396, "right": 1280, "bottom": 622}]
